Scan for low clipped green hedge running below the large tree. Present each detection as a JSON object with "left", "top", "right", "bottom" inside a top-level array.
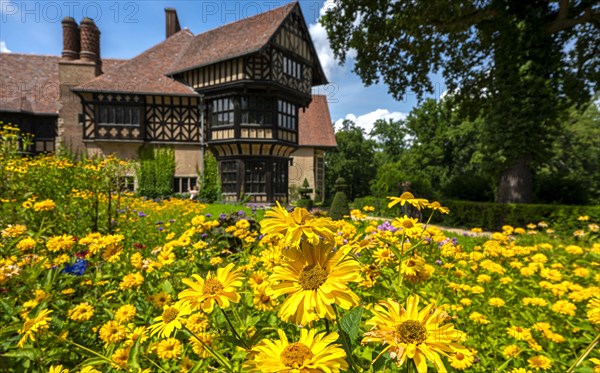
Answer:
[{"left": 352, "top": 197, "right": 600, "bottom": 232}]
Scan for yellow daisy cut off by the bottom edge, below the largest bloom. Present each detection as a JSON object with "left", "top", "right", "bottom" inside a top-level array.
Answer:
[{"left": 247, "top": 329, "right": 348, "bottom": 373}]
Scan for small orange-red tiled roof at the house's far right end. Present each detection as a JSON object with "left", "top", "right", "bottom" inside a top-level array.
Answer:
[{"left": 298, "top": 95, "right": 337, "bottom": 148}]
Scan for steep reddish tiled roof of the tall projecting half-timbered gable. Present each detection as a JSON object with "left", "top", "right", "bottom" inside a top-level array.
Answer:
[{"left": 170, "top": 2, "right": 297, "bottom": 74}]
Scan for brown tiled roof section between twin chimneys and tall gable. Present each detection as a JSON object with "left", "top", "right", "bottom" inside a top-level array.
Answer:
[{"left": 75, "top": 29, "right": 198, "bottom": 96}]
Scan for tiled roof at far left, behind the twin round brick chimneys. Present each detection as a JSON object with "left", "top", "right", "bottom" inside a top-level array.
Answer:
[{"left": 0, "top": 53, "right": 124, "bottom": 114}]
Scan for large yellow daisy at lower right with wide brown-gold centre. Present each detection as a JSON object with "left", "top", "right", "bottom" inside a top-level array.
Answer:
[{"left": 362, "top": 295, "right": 470, "bottom": 373}]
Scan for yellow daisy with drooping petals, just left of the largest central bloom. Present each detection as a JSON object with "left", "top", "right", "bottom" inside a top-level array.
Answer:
[{"left": 179, "top": 263, "right": 242, "bottom": 313}]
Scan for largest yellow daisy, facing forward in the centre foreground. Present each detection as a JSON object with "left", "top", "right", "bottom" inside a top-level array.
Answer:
[{"left": 269, "top": 242, "right": 360, "bottom": 325}]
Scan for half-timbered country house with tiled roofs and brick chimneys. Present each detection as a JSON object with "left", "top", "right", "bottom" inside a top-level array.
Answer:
[{"left": 0, "top": 2, "right": 336, "bottom": 202}]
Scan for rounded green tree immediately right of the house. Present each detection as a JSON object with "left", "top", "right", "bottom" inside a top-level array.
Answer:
[{"left": 325, "top": 120, "right": 377, "bottom": 201}]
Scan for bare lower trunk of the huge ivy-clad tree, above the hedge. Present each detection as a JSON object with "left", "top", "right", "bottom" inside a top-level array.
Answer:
[{"left": 497, "top": 157, "right": 533, "bottom": 203}]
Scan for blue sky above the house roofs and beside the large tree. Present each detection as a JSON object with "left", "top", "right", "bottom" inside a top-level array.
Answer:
[{"left": 0, "top": 0, "right": 444, "bottom": 132}]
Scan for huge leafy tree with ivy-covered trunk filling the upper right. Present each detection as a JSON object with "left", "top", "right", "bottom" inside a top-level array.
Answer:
[{"left": 322, "top": 0, "right": 600, "bottom": 202}]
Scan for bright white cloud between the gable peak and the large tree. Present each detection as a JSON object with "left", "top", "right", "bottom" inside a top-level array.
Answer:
[{"left": 308, "top": 0, "right": 356, "bottom": 78}]
